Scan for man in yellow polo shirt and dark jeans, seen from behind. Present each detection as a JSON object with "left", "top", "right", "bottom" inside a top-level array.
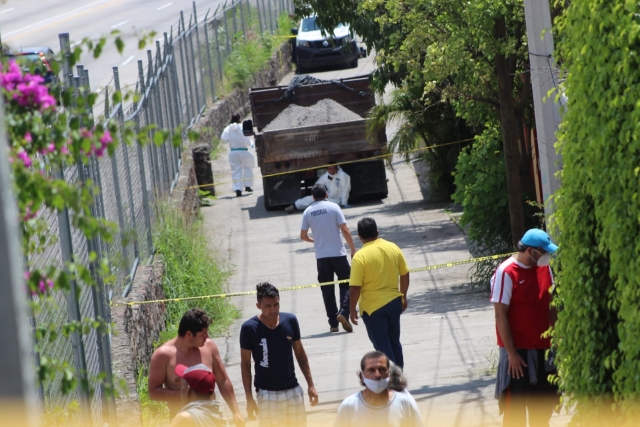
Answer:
[{"left": 349, "top": 217, "right": 409, "bottom": 368}]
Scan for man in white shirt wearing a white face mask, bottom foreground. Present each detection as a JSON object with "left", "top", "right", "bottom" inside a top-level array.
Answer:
[{"left": 335, "top": 351, "right": 423, "bottom": 427}]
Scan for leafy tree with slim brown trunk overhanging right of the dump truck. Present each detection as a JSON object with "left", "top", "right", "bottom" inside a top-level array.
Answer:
[{"left": 296, "top": 0, "right": 534, "bottom": 242}]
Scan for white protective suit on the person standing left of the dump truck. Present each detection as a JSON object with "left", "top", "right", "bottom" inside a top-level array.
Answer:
[{"left": 220, "top": 123, "right": 256, "bottom": 191}]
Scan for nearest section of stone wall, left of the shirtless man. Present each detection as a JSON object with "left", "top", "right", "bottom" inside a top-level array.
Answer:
[{"left": 111, "top": 256, "right": 165, "bottom": 425}]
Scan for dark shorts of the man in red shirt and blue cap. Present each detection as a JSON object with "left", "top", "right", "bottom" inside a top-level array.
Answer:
[{"left": 502, "top": 350, "right": 559, "bottom": 427}]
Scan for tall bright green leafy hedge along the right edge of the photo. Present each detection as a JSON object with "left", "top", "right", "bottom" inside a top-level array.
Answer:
[{"left": 554, "top": 0, "right": 640, "bottom": 425}]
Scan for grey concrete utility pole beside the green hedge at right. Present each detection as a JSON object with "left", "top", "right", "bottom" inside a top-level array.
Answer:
[{"left": 524, "top": 0, "right": 561, "bottom": 225}]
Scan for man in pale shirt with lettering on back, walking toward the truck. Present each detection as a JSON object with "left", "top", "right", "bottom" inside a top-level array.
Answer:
[{"left": 300, "top": 184, "right": 356, "bottom": 332}]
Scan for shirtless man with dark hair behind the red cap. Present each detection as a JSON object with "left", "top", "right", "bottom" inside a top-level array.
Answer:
[{"left": 149, "top": 308, "right": 244, "bottom": 427}]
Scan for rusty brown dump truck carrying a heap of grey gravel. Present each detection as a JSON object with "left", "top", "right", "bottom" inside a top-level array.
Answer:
[{"left": 249, "top": 75, "right": 388, "bottom": 210}]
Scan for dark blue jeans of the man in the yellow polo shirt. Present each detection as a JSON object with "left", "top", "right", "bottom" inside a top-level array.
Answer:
[{"left": 362, "top": 297, "right": 404, "bottom": 368}]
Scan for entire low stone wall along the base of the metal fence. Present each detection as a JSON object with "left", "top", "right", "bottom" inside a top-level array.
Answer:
[{"left": 111, "top": 42, "right": 291, "bottom": 425}]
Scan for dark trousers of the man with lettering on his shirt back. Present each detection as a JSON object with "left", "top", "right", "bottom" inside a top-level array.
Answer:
[{"left": 316, "top": 255, "right": 351, "bottom": 328}]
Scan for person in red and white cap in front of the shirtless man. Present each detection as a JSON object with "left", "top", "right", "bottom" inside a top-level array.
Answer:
[{"left": 171, "top": 363, "right": 227, "bottom": 427}]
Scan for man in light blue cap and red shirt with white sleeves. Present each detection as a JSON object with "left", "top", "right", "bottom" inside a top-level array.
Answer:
[{"left": 491, "top": 228, "right": 558, "bottom": 427}]
